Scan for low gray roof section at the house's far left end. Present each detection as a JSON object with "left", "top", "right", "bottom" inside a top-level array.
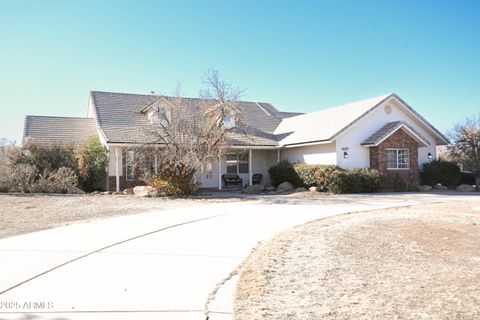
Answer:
[{"left": 23, "top": 116, "right": 97, "bottom": 145}]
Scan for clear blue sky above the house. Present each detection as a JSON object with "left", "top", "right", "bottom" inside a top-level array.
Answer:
[{"left": 0, "top": 0, "right": 480, "bottom": 141}]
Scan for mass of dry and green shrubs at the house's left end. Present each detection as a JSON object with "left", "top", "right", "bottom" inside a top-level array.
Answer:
[{"left": 0, "top": 137, "right": 108, "bottom": 193}]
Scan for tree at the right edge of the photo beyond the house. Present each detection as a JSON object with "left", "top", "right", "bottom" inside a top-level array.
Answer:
[{"left": 448, "top": 116, "right": 480, "bottom": 188}]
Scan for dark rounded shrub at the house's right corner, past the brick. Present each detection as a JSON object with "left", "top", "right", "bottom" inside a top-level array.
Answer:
[{"left": 420, "top": 159, "right": 461, "bottom": 188}]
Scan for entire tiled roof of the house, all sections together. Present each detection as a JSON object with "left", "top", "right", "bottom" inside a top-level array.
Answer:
[{"left": 24, "top": 91, "right": 448, "bottom": 147}]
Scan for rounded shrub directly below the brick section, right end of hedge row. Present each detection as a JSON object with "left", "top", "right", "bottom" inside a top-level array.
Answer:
[{"left": 328, "top": 169, "right": 383, "bottom": 193}]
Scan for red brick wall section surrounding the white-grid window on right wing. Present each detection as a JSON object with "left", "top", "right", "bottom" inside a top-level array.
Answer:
[{"left": 370, "top": 129, "right": 419, "bottom": 190}]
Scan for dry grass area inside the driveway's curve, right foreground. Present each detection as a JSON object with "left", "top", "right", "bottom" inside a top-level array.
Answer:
[{"left": 235, "top": 201, "right": 480, "bottom": 320}]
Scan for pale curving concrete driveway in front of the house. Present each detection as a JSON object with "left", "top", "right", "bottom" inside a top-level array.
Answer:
[{"left": 0, "top": 193, "right": 478, "bottom": 320}]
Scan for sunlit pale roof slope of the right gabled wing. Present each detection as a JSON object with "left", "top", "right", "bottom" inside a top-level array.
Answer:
[{"left": 275, "top": 94, "right": 393, "bottom": 145}]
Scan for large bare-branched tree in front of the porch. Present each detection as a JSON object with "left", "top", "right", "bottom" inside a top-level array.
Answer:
[{"left": 136, "top": 70, "right": 248, "bottom": 194}]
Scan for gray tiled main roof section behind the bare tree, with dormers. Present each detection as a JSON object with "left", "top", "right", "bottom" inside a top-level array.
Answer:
[{"left": 91, "top": 91, "right": 297, "bottom": 146}]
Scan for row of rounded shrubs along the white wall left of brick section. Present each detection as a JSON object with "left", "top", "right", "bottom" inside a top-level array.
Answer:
[{"left": 268, "top": 161, "right": 383, "bottom": 193}]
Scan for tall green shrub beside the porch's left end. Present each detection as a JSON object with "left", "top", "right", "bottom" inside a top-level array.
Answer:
[{"left": 76, "top": 136, "right": 108, "bottom": 191}]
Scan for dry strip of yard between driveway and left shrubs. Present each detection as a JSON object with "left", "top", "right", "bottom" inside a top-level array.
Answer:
[{"left": 0, "top": 194, "right": 239, "bottom": 239}]
